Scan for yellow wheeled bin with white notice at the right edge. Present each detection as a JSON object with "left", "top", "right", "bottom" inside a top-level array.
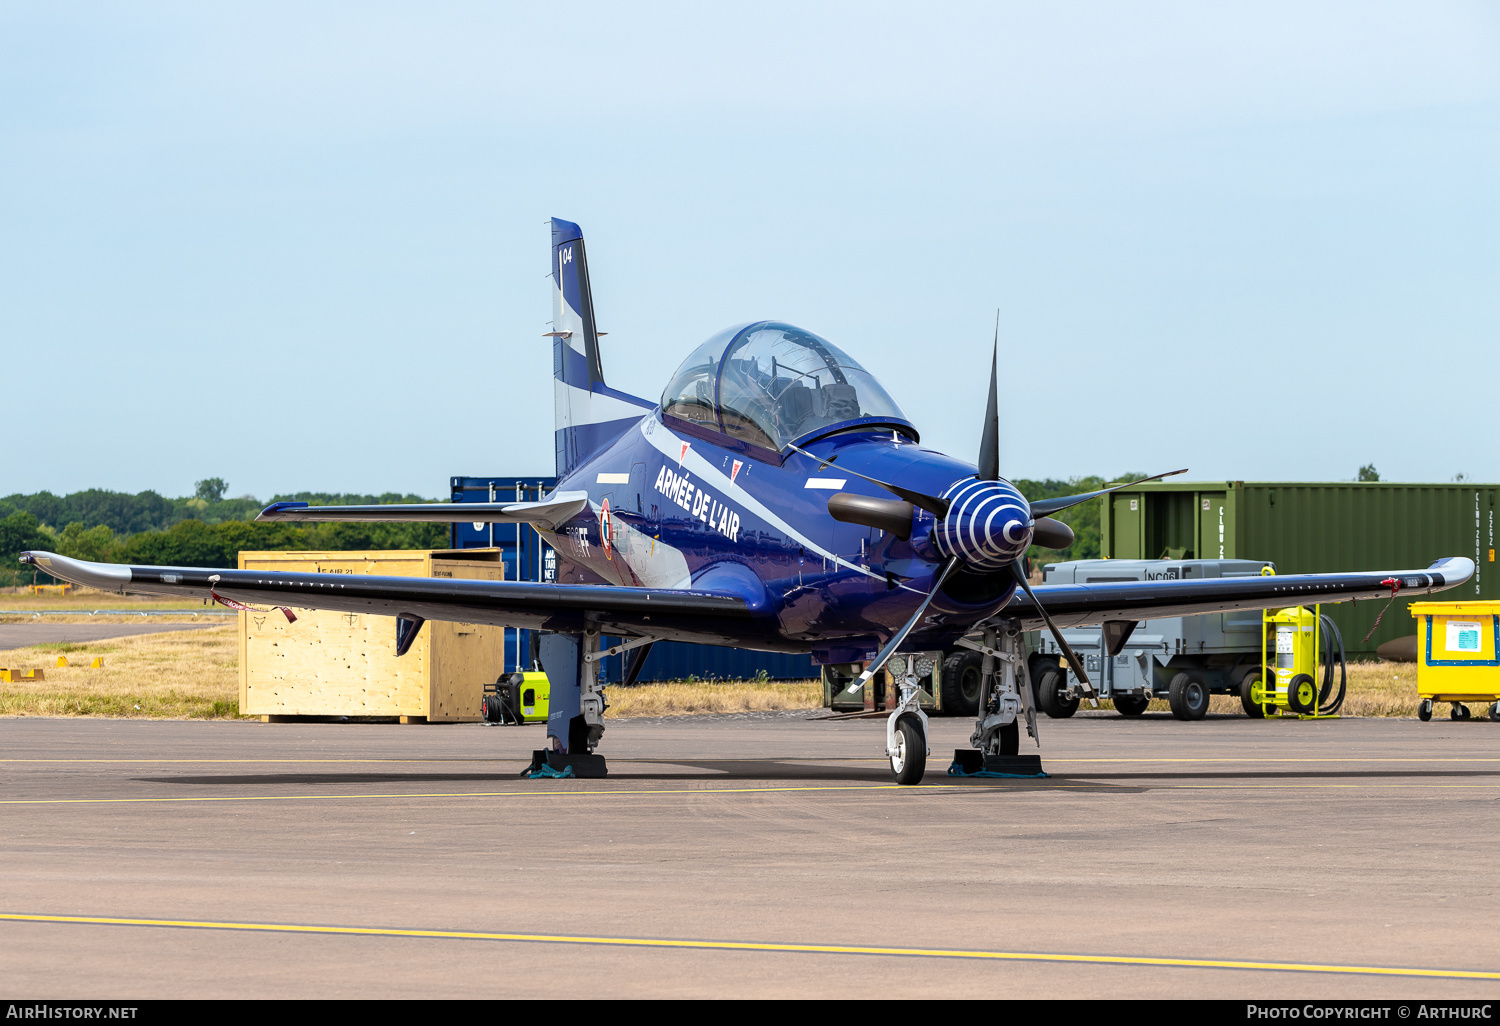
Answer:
[{"left": 1412, "top": 600, "right": 1500, "bottom": 722}]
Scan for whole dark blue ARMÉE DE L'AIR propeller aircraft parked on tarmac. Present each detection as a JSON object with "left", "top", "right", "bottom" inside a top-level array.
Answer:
[{"left": 23, "top": 219, "right": 1475, "bottom": 783}]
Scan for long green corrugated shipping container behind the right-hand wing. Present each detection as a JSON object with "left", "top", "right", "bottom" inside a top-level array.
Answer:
[{"left": 1100, "top": 482, "right": 1500, "bottom": 659}]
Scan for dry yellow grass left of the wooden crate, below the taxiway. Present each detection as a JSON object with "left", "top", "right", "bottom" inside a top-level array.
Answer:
[{"left": 0, "top": 621, "right": 240, "bottom": 720}]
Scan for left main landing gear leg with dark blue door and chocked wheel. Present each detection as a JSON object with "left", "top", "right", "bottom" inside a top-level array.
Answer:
[{"left": 522, "top": 630, "right": 608, "bottom": 777}]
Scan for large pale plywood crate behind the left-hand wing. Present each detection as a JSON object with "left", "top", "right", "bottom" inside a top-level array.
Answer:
[{"left": 240, "top": 549, "right": 506, "bottom": 723}]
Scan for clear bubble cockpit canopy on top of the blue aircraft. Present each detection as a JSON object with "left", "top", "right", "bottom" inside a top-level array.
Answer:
[{"left": 662, "top": 321, "right": 911, "bottom": 452}]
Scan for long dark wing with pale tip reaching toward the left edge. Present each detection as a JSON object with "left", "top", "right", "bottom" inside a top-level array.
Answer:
[{"left": 21, "top": 552, "right": 764, "bottom": 648}]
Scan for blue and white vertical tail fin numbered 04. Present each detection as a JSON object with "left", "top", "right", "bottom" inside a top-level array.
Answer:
[{"left": 549, "top": 218, "right": 653, "bottom": 477}]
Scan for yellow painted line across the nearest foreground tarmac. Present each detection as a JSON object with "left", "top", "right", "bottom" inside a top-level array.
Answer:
[{"left": 0, "top": 912, "right": 1500, "bottom": 980}]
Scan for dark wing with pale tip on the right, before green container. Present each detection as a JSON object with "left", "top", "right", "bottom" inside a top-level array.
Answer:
[{"left": 1001, "top": 557, "right": 1475, "bottom": 630}]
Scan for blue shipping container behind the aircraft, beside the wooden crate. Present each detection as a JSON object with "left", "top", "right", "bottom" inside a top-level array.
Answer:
[{"left": 450, "top": 477, "right": 819, "bottom": 681}]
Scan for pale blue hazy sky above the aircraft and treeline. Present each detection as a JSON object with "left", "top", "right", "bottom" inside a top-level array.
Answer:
[{"left": 0, "top": 0, "right": 1500, "bottom": 498}]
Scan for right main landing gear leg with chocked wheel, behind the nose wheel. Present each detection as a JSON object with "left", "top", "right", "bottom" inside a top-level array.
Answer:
[{"left": 948, "top": 624, "right": 1047, "bottom": 777}]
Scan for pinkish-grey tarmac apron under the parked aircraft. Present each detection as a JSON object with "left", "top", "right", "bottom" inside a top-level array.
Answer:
[{"left": 0, "top": 713, "right": 1500, "bottom": 999}]
